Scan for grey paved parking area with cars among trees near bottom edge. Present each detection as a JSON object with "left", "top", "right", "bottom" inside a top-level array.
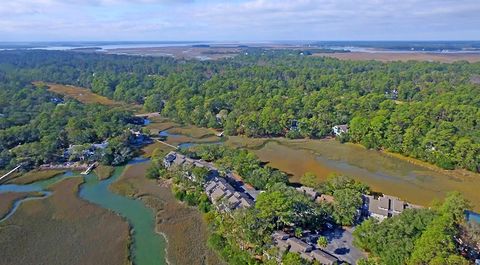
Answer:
[{"left": 322, "top": 225, "right": 365, "bottom": 264}]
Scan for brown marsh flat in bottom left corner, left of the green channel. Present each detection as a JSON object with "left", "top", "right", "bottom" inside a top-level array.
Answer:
[{"left": 0, "top": 178, "right": 129, "bottom": 265}]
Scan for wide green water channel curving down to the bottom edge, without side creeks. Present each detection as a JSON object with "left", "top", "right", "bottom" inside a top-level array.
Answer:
[{"left": 79, "top": 163, "right": 167, "bottom": 265}]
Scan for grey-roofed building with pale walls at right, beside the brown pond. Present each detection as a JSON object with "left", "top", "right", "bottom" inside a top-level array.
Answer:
[{"left": 363, "top": 195, "right": 420, "bottom": 221}]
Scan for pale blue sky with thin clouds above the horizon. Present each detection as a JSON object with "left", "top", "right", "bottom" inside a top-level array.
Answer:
[{"left": 0, "top": 0, "right": 480, "bottom": 41}]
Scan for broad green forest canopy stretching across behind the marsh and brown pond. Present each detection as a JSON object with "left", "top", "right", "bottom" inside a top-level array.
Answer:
[{"left": 0, "top": 49, "right": 480, "bottom": 172}]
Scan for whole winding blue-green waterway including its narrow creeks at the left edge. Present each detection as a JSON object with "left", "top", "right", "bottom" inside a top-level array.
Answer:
[{"left": 0, "top": 159, "right": 167, "bottom": 265}]
